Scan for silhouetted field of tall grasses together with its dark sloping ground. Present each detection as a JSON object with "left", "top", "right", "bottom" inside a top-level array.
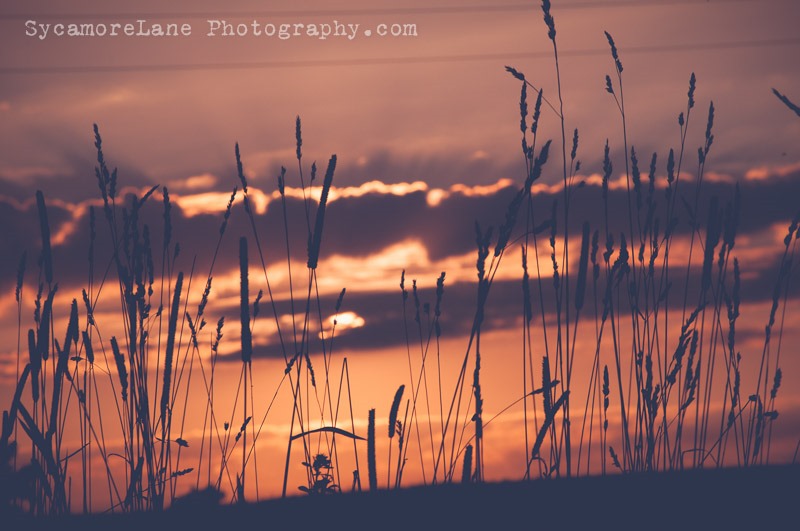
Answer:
[{"left": 0, "top": 1, "right": 800, "bottom": 528}]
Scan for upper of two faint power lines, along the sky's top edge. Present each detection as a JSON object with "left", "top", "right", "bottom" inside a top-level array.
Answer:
[{"left": 0, "top": 0, "right": 780, "bottom": 20}]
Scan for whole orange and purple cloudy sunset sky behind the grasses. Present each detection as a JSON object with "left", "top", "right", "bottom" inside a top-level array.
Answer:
[{"left": 0, "top": 0, "right": 800, "bottom": 510}]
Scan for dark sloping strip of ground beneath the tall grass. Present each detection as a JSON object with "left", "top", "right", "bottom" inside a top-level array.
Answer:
[{"left": 3, "top": 465, "right": 800, "bottom": 531}]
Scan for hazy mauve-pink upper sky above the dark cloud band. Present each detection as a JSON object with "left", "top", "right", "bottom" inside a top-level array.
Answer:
[{"left": 0, "top": 0, "right": 800, "bottom": 199}]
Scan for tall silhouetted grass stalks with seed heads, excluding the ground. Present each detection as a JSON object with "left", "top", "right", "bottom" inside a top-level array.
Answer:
[{"left": 0, "top": 0, "right": 800, "bottom": 523}]
